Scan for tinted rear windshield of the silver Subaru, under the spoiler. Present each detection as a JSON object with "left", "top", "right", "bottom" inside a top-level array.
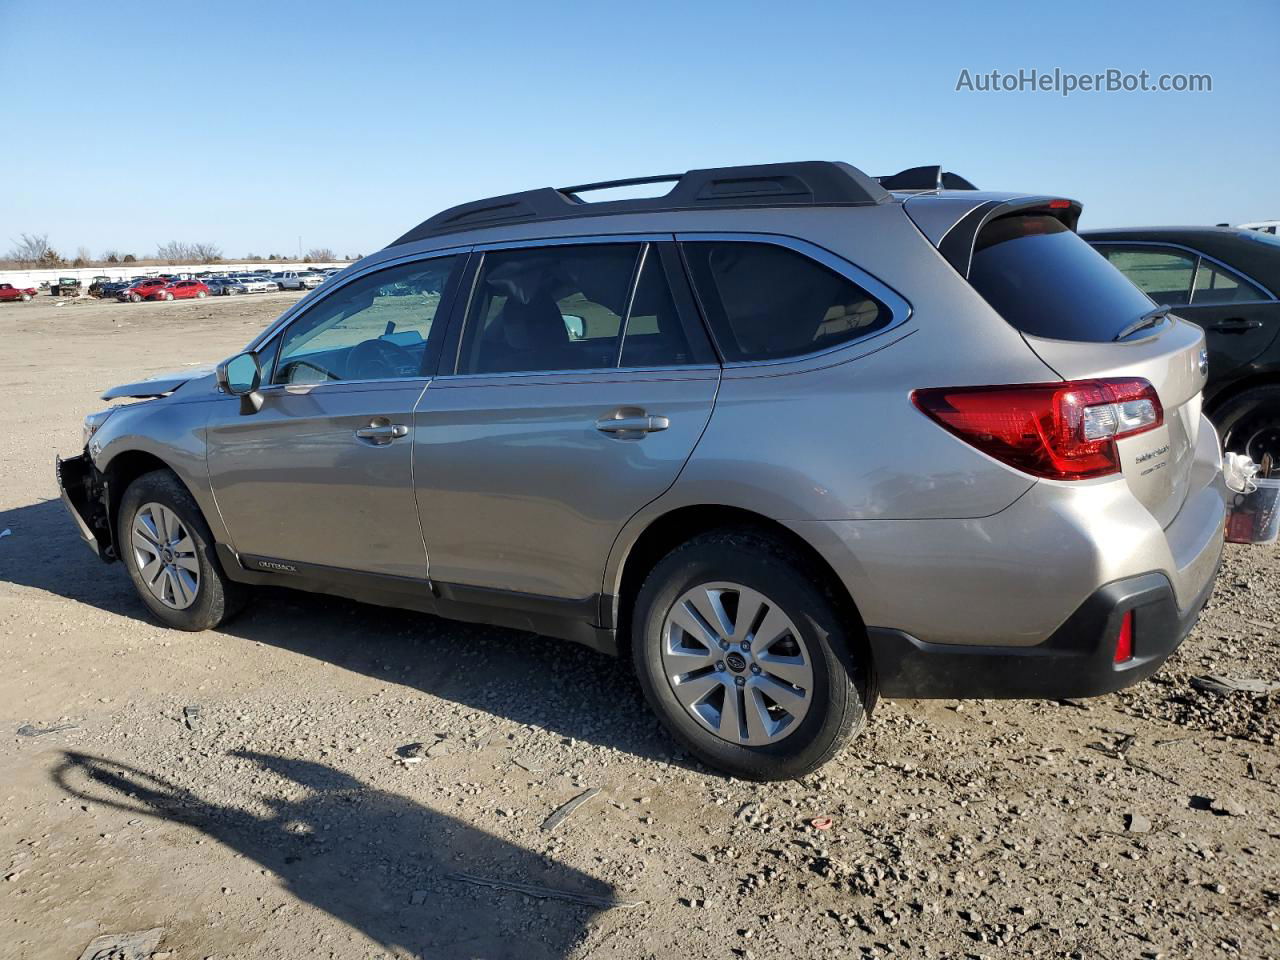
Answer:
[{"left": 969, "top": 215, "right": 1152, "bottom": 343}]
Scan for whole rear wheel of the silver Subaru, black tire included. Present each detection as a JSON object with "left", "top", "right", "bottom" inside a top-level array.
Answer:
[{"left": 631, "top": 530, "right": 874, "bottom": 781}]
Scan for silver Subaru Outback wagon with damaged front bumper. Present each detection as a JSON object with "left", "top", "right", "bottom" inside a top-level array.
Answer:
[{"left": 58, "top": 161, "right": 1224, "bottom": 780}]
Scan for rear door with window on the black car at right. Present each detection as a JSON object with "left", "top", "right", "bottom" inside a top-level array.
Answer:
[{"left": 1094, "top": 243, "right": 1280, "bottom": 394}]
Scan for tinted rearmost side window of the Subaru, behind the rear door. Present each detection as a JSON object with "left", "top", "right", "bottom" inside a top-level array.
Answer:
[{"left": 684, "top": 241, "right": 892, "bottom": 362}]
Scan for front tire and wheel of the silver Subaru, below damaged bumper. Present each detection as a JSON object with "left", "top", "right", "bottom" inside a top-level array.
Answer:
[{"left": 116, "top": 470, "right": 246, "bottom": 631}]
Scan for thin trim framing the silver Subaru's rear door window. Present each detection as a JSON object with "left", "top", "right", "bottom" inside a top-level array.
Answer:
[{"left": 436, "top": 232, "right": 719, "bottom": 380}]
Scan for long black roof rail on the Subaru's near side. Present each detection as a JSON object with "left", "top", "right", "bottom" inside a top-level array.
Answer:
[{"left": 390, "top": 160, "right": 890, "bottom": 247}]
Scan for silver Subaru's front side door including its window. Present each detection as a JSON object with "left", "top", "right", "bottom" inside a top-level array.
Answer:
[{"left": 209, "top": 257, "right": 463, "bottom": 580}]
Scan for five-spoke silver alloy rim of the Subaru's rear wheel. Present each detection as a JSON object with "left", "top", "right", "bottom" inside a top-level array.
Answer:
[{"left": 662, "top": 581, "right": 814, "bottom": 746}]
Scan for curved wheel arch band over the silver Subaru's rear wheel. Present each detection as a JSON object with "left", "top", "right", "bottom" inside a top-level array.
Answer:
[{"left": 607, "top": 503, "right": 865, "bottom": 657}]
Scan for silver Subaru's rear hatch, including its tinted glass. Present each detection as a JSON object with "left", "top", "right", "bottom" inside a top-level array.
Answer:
[{"left": 968, "top": 208, "right": 1207, "bottom": 527}]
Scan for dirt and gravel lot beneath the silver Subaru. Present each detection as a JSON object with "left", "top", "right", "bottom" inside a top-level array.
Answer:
[{"left": 0, "top": 294, "right": 1280, "bottom": 960}]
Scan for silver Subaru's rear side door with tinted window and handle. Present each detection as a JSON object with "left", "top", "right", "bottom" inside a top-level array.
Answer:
[{"left": 413, "top": 237, "right": 719, "bottom": 601}]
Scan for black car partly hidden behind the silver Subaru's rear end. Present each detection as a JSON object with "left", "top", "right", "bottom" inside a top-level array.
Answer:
[{"left": 1082, "top": 227, "right": 1280, "bottom": 463}]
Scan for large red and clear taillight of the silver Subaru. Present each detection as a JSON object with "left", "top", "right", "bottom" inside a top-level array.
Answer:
[{"left": 911, "top": 378, "right": 1165, "bottom": 480}]
